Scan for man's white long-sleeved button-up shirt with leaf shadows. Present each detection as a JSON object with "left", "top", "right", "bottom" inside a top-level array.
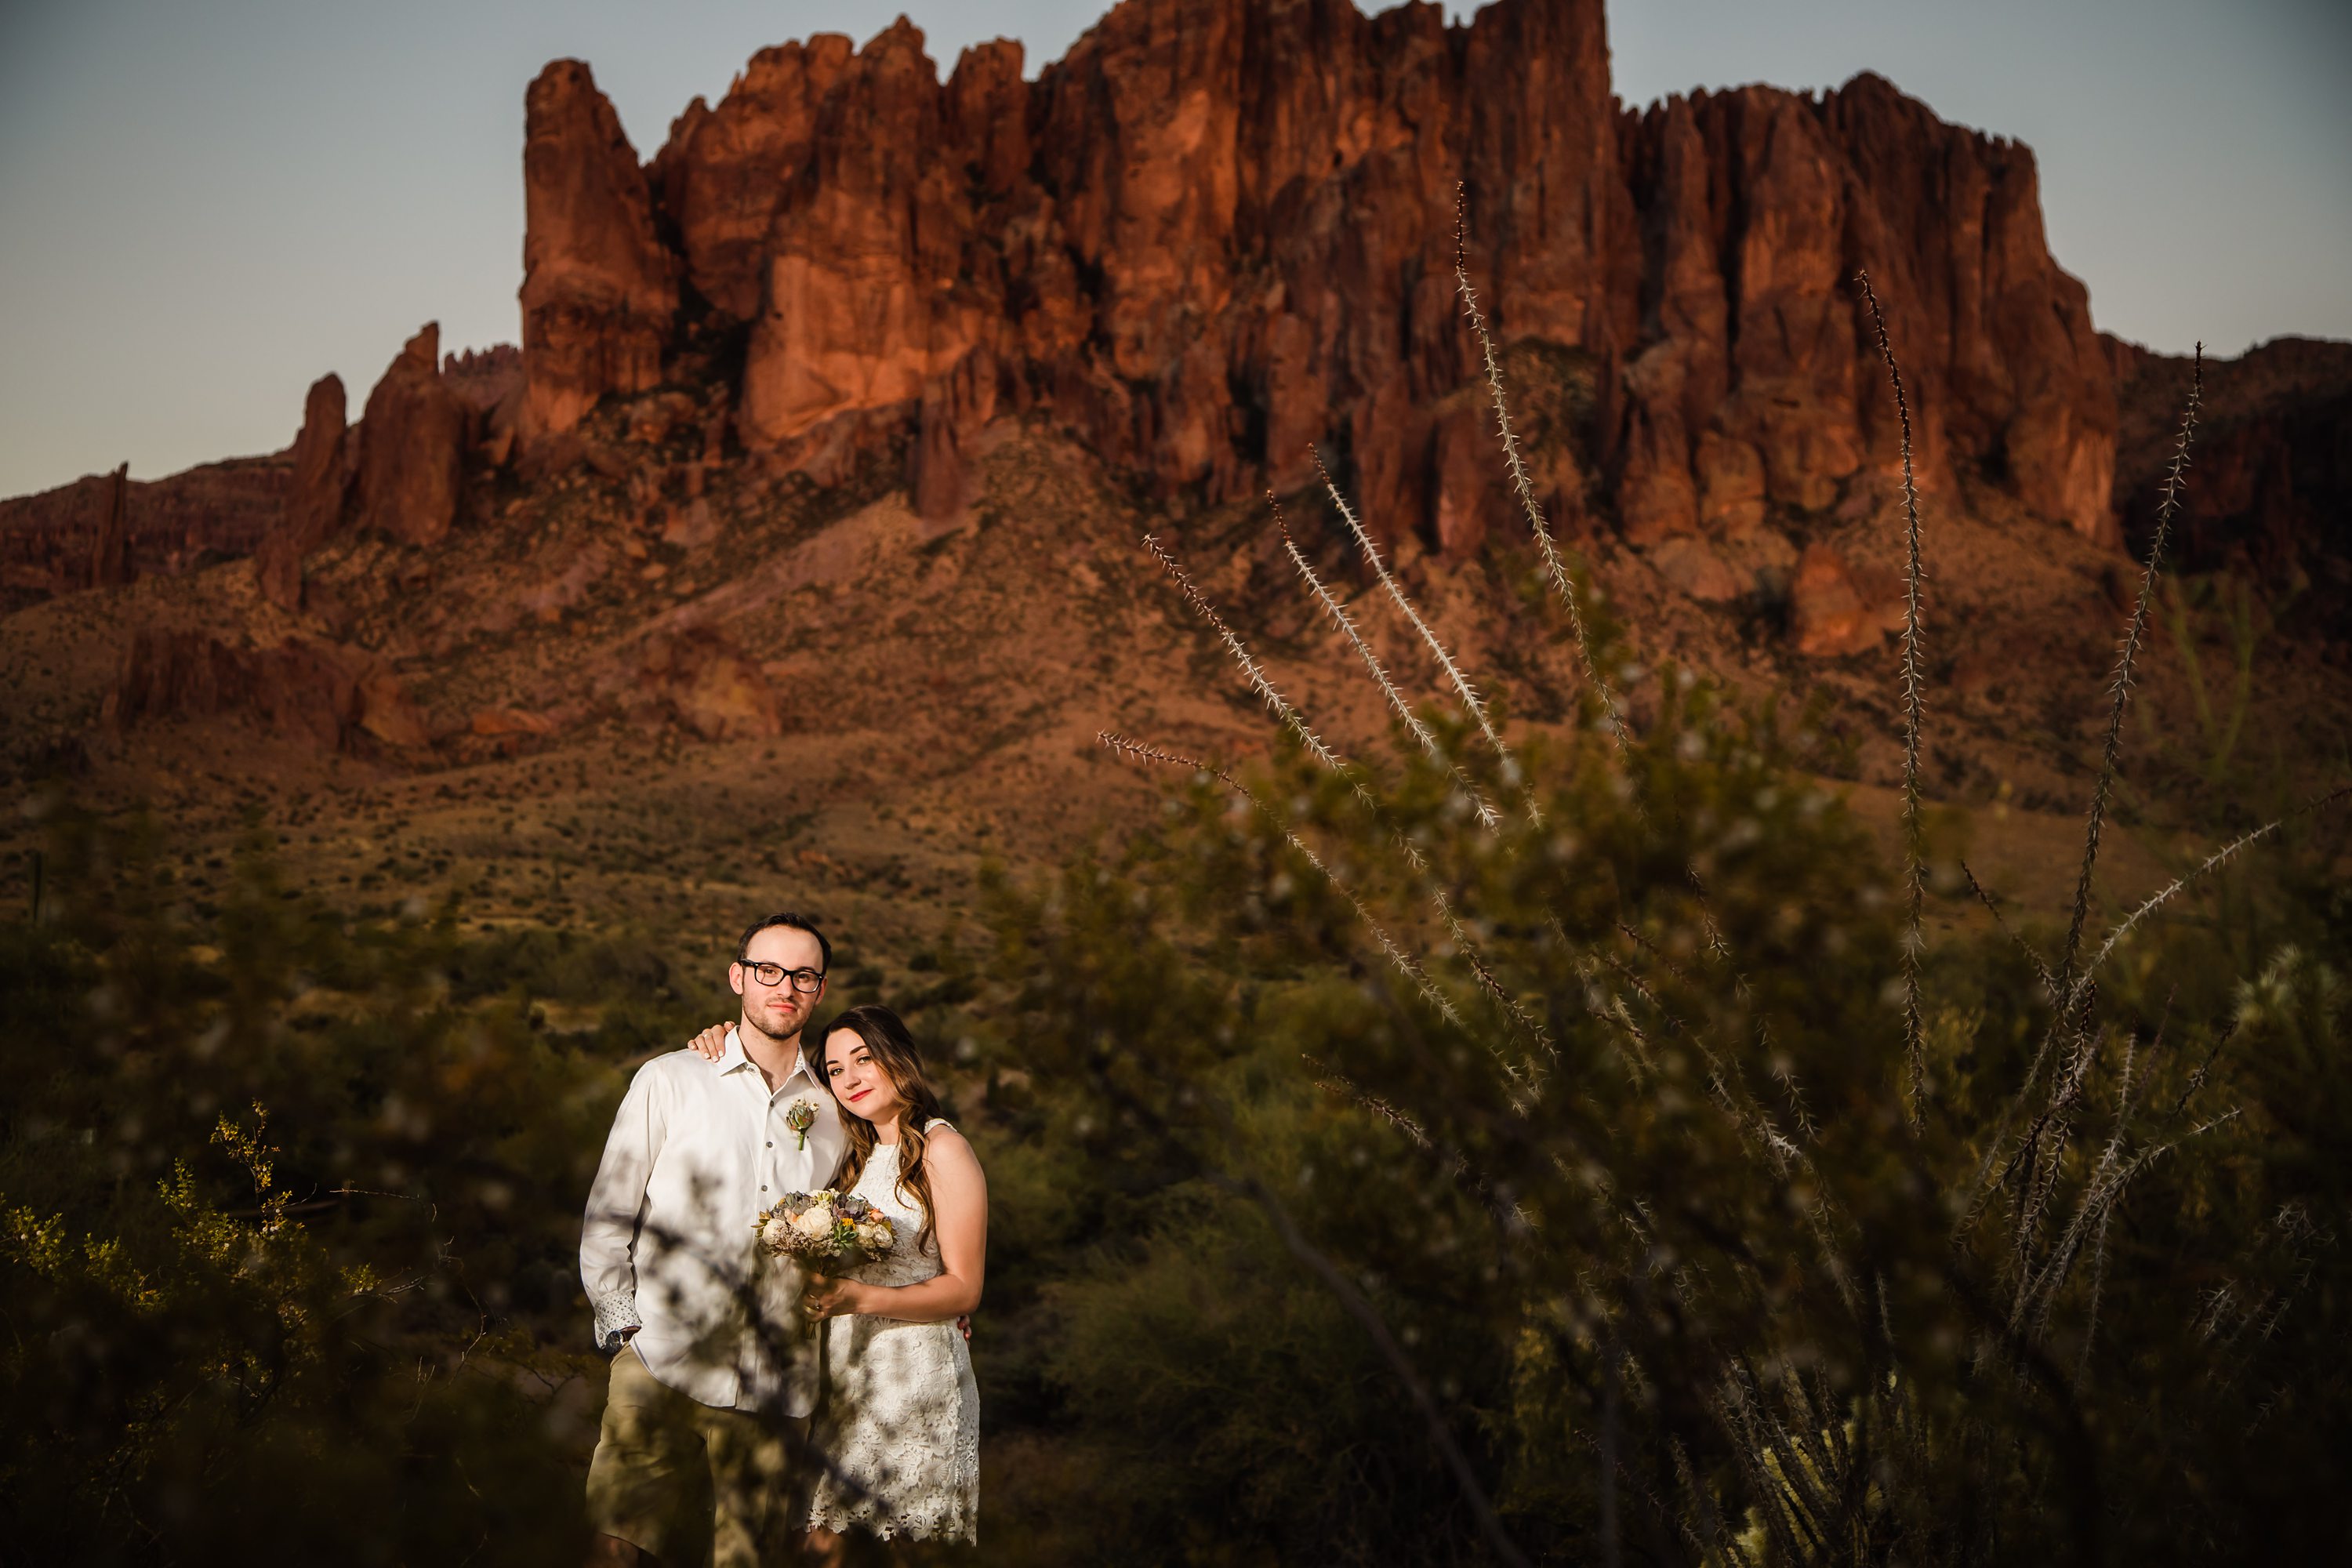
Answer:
[{"left": 581, "top": 1029, "right": 849, "bottom": 1415}]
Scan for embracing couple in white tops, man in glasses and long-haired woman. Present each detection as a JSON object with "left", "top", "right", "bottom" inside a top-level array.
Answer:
[{"left": 581, "top": 914, "right": 988, "bottom": 1568}]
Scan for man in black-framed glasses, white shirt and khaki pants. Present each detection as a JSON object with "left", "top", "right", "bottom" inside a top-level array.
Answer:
[{"left": 581, "top": 914, "right": 847, "bottom": 1568}]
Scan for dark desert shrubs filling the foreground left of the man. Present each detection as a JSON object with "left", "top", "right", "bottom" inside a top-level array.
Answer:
[{"left": 0, "top": 811, "right": 682, "bottom": 1563}]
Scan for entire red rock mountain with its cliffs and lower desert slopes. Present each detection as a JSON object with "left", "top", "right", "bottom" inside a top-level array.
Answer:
[{"left": 0, "top": 0, "right": 2352, "bottom": 968}]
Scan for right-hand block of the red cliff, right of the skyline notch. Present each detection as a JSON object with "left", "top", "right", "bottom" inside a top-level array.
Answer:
[{"left": 1618, "top": 75, "right": 2117, "bottom": 541}]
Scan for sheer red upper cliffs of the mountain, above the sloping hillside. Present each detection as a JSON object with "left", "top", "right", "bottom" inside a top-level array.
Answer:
[{"left": 522, "top": 0, "right": 2117, "bottom": 553}]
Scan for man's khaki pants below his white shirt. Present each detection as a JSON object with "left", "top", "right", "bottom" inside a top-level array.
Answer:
[{"left": 588, "top": 1347, "right": 809, "bottom": 1568}]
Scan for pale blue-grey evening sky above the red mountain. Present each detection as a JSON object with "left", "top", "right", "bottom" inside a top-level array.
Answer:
[{"left": 0, "top": 0, "right": 2352, "bottom": 496}]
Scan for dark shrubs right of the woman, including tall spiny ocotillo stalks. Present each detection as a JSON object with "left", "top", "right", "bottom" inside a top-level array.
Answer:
[{"left": 946, "top": 288, "right": 2352, "bottom": 1563}]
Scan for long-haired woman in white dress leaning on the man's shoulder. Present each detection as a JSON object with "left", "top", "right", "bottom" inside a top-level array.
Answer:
[{"left": 696, "top": 1006, "right": 988, "bottom": 1563}]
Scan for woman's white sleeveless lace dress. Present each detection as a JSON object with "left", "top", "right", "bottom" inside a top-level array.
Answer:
[{"left": 809, "top": 1121, "right": 981, "bottom": 1542}]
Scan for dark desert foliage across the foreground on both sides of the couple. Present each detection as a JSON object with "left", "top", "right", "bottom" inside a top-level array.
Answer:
[{"left": 0, "top": 691, "right": 2352, "bottom": 1563}]
